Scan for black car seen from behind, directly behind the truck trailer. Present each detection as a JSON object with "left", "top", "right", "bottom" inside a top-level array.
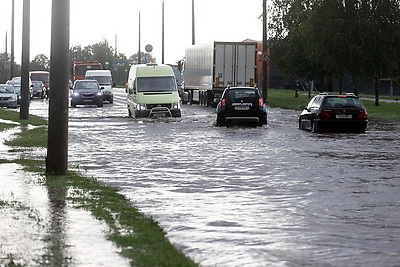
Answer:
[{"left": 217, "top": 87, "right": 267, "bottom": 126}]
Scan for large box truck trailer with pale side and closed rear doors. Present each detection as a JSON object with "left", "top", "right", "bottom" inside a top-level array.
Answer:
[{"left": 181, "top": 42, "right": 257, "bottom": 106}]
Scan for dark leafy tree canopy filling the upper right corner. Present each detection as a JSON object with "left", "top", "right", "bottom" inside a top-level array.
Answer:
[{"left": 269, "top": 0, "right": 400, "bottom": 100}]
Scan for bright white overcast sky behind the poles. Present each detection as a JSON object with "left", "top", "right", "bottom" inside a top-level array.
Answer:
[{"left": 0, "top": 0, "right": 262, "bottom": 64}]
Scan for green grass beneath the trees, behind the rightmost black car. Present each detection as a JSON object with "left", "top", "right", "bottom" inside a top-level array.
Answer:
[{"left": 268, "top": 89, "right": 400, "bottom": 121}]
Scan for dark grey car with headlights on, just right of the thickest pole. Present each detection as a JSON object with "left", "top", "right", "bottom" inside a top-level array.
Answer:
[{"left": 71, "top": 80, "right": 103, "bottom": 107}]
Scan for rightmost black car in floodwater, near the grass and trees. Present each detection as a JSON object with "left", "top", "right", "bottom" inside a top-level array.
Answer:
[{"left": 299, "top": 93, "right": 368, "bottom": 133}]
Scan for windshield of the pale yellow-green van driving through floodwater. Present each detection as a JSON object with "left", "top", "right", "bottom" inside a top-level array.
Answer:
[{"left": 137, "top": 76, "right": 177, "bottom": 92}]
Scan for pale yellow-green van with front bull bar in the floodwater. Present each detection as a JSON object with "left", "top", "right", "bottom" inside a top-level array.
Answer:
[{"left": 126, "top": 63, "right": 181, "bottom": 118}]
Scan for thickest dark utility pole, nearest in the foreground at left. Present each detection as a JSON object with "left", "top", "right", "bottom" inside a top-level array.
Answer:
[{"left": 46, "top": 0, "right": 70, "bottom": 175}]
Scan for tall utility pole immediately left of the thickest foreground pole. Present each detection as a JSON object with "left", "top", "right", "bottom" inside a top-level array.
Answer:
[{"left": 19, "top": 0, "right": 31, "bottom": 120}]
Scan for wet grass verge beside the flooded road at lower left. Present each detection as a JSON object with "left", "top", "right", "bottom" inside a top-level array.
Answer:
[{"left": 0, "top": 110, "right": 197, "bottom": 266}]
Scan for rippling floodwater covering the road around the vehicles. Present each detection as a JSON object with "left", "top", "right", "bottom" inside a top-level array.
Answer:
[{"left": 30, "top": 89, "right": 400, "bottom": 266}]
